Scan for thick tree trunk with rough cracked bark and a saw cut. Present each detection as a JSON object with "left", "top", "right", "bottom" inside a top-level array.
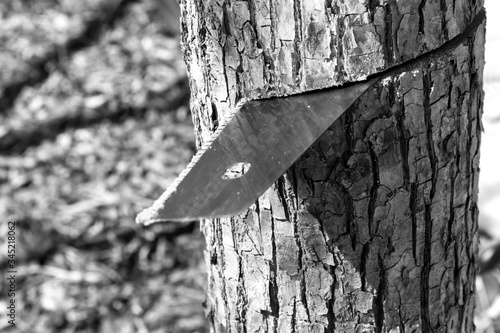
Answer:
[{"left": 181, "top": 0, "right": 484, "bottom": 332}]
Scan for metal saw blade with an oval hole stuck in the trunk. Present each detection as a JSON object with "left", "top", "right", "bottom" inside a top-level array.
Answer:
[{"left": 137, "top": 78, "right": 377, "bottom": 224}]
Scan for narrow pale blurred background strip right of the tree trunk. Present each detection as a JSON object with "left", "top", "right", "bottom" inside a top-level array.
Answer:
[{"left": 475, "top": 0, "right": 500, "bottom": 333}]
